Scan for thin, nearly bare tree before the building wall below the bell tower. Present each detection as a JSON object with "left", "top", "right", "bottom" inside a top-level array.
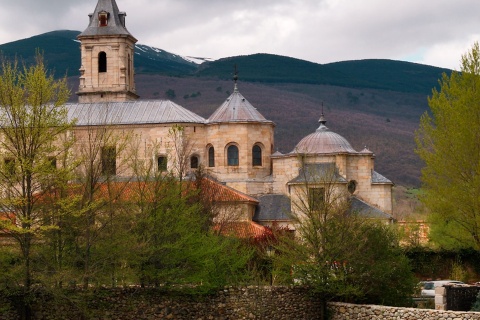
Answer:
[{"left": 69, "top": 105, "right": 132, "bottom": 287}]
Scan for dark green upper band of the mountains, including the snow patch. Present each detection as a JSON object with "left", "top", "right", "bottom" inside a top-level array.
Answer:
[{"left": 0, "top": 30, "right": 450, "bottom": 94}]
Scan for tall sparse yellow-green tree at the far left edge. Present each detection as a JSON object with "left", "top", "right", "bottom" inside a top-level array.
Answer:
[{"left": 0, "top": 54, "right": 73, "bottom": 288}]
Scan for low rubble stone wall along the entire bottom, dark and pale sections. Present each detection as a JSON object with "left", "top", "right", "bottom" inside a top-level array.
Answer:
[{"left": 4, "top": 286, "right": 480, "bottom": 320}]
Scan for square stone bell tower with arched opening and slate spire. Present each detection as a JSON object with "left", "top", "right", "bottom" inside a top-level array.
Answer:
[{"left": 77, "top": 0, "right": 139, "bottom": 103}]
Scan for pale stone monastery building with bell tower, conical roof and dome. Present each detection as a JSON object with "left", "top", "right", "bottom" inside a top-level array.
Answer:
[{"left": 55, "top": 0, "right": 393, "bottom": 227}]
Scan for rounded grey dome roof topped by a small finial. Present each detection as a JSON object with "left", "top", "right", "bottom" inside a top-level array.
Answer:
[{"left": 291, "top": 114, "right": 357, "bottom": 154}]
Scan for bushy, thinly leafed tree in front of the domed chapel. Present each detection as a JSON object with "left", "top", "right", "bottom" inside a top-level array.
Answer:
[{"left": 275, "top": 159, "right": 415, "bottom": 305}]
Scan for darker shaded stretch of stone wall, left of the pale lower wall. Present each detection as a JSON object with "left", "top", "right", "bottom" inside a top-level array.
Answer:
[{"left": 0, "top": 287, "right": 321, "bottom": 320}]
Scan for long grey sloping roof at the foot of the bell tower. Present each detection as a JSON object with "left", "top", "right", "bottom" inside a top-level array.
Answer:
[{"left": 66, "top": 100, "right": 205, "bottom": 126}]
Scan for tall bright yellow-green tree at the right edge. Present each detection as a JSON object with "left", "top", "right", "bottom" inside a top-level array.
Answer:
[{"left": 416, "top": 43, "right": 480, "bottom": 250}]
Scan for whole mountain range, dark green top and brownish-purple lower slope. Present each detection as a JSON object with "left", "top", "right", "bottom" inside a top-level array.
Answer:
[{"left": 0, "top": 30, "right": 451, "bottom": 186}]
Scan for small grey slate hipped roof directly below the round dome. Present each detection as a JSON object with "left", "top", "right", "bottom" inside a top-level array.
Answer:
[{"left": 288, "top": 162, "right": 347, "bottom": 184}]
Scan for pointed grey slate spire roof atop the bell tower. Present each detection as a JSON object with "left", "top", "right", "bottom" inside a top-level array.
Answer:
[{"left": 78, "top": 0, "right": 136, "bottom": 41}]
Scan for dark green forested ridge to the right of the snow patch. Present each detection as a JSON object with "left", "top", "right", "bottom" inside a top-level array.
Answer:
[{"left": 196, "top": 54, "right": 450, "bottom": 94}]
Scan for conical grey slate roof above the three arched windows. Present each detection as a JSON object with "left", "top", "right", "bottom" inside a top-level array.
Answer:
[{"left": 207, "top": 85, "right": 273, "bottom": 123}]
